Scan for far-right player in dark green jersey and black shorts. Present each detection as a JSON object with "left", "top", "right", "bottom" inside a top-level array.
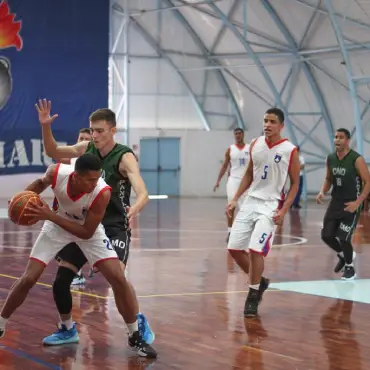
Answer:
[{"left": 316, "top": 128, "right": 370, "bottom": 280}]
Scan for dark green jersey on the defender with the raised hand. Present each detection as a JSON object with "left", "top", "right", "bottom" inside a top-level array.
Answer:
[{"left": 86, "top": 142, "right": 133, "bottom": 229}]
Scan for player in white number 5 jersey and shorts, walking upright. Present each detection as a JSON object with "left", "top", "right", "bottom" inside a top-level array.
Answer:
[{"left": 227, "top": 108, "right": 300, "bottom": 317}]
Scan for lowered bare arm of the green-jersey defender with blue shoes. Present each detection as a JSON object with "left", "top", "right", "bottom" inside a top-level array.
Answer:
[{"left": 119, "top": 153, "right": 149, "bottom": 218}]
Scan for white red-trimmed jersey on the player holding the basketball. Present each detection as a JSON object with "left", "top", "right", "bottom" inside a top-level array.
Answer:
[{"left": 42, "top": 163, "right": 111, "bottom": 240}]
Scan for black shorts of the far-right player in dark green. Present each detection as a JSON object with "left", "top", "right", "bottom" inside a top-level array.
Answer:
[{"left": 322, "top": 199, "right": 360, "bottom": 241}]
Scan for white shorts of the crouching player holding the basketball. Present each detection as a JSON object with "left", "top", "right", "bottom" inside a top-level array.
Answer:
[{"left": 30, "top": 223, "right": 118, "bottom": 267}]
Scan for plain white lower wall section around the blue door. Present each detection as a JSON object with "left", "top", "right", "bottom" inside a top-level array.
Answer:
[{"left": 127, "top": 129, "right": 234, "bottom": 197}]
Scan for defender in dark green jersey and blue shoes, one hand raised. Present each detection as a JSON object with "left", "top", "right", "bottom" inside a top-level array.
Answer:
[{"left": 36, "top": 99, "right": 155, "bottom": 345}]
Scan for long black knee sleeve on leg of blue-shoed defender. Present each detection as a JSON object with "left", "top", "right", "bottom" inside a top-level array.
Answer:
[{"left": 53, "top": 266, "right": 76, "bottom": 315}]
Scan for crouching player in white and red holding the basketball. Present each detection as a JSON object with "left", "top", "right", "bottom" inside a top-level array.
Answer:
[{"left": 0, "top": 153, "right": 157, "bottom": 358}]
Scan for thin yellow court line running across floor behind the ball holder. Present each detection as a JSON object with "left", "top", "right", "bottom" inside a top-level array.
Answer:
[{"left": 0, "top": 274, "right": 281, "bottom": 300}]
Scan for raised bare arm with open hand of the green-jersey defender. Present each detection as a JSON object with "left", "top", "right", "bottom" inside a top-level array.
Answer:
[{"left": 35, "top": 99, "right": 89, "bottom": 158}]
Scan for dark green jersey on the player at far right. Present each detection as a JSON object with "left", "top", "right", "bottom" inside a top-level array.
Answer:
[{"left": 327, "top": 149, "right": 362, "bottom": 201}]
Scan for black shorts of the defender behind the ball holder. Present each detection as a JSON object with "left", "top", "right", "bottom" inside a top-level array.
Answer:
[{"left": 55, "top": 227, "right": 131, "bottom": 270}]
